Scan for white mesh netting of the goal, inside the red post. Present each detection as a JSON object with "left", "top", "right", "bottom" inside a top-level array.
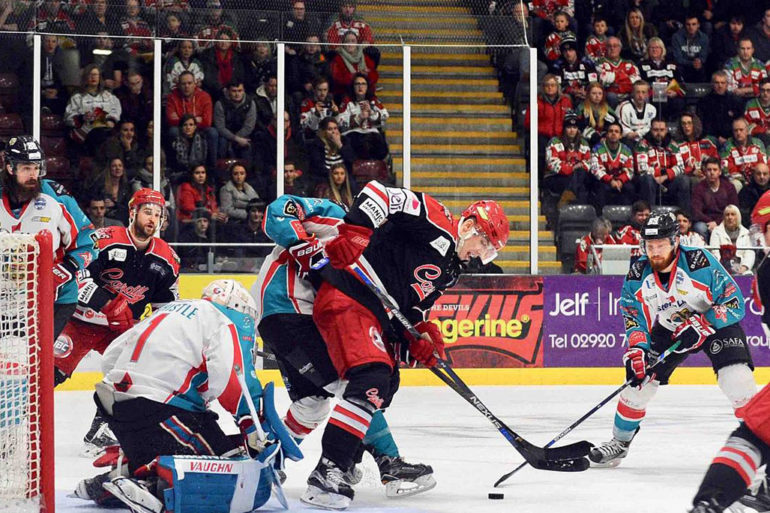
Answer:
[{"left": 0, "top": 233, "right": 42, "bottom": 513}]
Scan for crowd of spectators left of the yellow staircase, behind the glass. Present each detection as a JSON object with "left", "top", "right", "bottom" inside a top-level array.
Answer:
[{"left": 0, "top": 0, "right": 392, "bottom": 270}]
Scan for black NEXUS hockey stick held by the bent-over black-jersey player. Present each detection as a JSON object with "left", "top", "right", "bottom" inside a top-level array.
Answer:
[{"left": 350, "top": 264, "right": 592, "bottom": 472}]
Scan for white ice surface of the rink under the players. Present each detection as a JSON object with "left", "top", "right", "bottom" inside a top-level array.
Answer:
[{"left": 56, "top": 385, "right": 737, "bottom": 513}]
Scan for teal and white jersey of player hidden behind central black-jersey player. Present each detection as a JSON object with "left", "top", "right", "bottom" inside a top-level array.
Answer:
[{"left": 251, "top": 194, "right": 345, "bottom": 323}]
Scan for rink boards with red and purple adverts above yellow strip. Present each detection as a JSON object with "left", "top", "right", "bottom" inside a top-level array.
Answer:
[{"left": 60, "top": 274, "right": 770, "bottom": 390}]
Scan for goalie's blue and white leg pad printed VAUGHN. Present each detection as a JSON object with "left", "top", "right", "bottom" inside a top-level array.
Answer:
[{"left": 158, "top": 456, "right": 273, "bottom": 513}]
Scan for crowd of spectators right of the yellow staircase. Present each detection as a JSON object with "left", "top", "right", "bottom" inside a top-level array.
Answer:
[{"left": 512, "top": 0, "right": 770, "bottom": 274}]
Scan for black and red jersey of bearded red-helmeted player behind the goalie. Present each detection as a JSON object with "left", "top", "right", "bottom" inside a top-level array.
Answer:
[{"left": 74, "top": 226, "right": 179, "bottom": 325}]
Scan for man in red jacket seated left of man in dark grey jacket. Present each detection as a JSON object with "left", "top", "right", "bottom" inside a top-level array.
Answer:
[{"left": 166, "top": 71, "right": 219, "bottom": 167}]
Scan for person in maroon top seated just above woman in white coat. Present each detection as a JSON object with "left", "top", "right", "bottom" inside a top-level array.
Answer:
[{"left": 692, "top": 158, "right": 738, "bottom": 240}]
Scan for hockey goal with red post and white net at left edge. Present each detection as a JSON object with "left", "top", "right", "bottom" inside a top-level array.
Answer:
[{"left": 0, "top": 232, "right": 54, "bottom": 513}]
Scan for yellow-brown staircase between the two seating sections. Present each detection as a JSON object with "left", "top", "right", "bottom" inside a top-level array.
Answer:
[{"left": 357, "top": 0, "right": 561, "bottom": 274}]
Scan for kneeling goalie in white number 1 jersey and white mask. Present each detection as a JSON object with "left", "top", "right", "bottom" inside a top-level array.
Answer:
[{"left": 75, "top": 280, "right": 302, "bottom": 513}]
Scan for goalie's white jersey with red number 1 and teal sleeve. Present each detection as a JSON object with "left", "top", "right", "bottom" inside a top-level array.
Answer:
[{"left": 102, "top": 299, "right": 262, "bottom": 419}]
